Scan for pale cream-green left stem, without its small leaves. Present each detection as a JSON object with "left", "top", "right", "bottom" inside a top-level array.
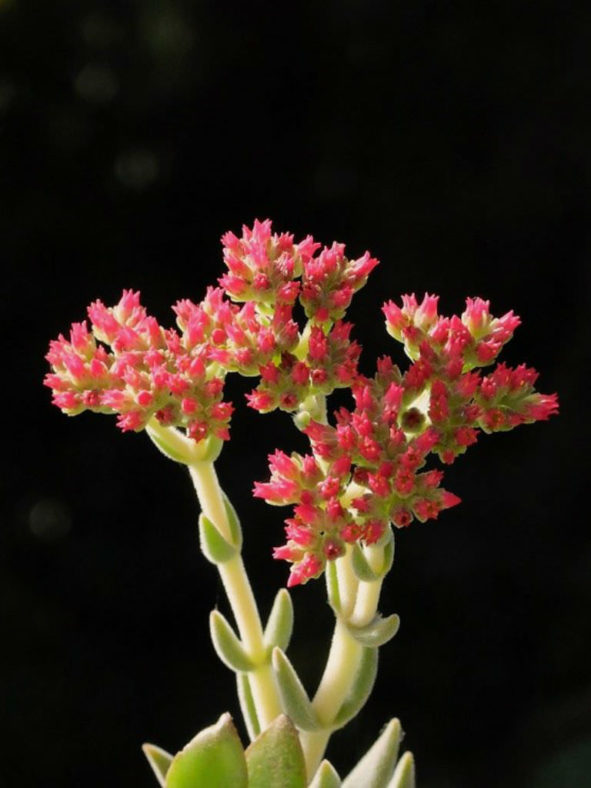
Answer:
[{"left": 189, "top": 462, "right": 281, "bottom": 730}]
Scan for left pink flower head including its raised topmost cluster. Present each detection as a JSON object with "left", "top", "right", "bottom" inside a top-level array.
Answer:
[{"left": 45, "top": 220, "right": 377, "bottom": 440}]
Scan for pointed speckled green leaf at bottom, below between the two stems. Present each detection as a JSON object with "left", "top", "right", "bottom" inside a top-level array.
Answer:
[{"left": 245, "top": 714, "right": 306, "bottom": 788}]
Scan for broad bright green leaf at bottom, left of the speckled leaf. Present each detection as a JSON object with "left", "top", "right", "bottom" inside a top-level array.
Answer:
[{"left": 165, "top": 714, "right": 248, "bottom": 788}]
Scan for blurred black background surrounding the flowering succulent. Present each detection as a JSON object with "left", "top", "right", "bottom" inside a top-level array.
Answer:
[{"left": 0, "top": 0, "right": 591, "bottom": 788}]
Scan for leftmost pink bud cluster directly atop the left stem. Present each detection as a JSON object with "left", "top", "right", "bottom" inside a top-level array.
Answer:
[{"left": 44, "top": 290, "right": 232, "bottom": 440}]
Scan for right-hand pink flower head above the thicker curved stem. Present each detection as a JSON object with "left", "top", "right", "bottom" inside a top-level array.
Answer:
[{"left": 254, "top": 295, "right": 558, "bottom": 585}]
